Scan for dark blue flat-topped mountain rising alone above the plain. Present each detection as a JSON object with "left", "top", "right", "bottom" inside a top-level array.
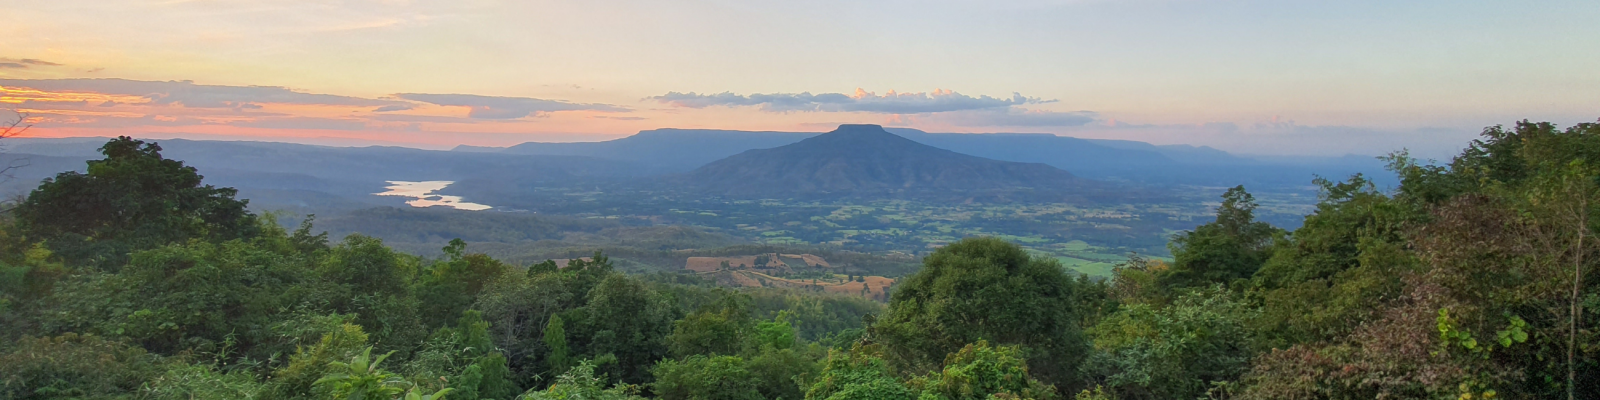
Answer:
[{"left": 685, "top": 125, "right": 1093, "bottom": 197}]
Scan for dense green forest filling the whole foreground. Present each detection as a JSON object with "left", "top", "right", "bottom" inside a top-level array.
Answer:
[{"left": 0, "top": 122, "right": 1600, "bottom": 400}]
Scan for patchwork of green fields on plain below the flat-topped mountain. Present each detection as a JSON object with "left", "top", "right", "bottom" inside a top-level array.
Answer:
[{"left": 438, "top": 187, "right": 1317, "bottom": 277}]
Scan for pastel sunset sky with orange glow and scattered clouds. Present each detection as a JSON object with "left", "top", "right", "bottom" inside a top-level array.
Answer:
[{"left": 0, "top": 0, "right": 1600, "bottom": 158}]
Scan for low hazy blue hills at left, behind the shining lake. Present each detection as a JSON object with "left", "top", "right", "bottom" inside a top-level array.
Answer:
[{"left": 0, "top": 138, "right": 645, "bottom": 210}]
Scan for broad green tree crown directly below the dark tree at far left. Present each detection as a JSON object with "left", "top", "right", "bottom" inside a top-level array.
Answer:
[{"left": 43, "top": 235, "right": 314, "bottom": 358}]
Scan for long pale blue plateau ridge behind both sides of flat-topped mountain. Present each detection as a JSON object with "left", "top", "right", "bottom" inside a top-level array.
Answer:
[{"left": 454, "top": 128, "right": 1382, "bottom": 187}]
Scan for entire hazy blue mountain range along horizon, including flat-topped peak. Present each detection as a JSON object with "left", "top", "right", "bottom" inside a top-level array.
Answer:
[{"left": 0, "top": 126, "right": 1387, "bottom": 210}]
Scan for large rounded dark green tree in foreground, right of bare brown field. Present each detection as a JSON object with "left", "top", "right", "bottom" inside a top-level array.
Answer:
[{"left": 869, "top": 238, "right": 1086, "bottom": 389}]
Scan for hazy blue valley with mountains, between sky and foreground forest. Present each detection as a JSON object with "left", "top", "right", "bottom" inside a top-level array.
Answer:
[{"left": 8, "top": 125, "right": 1337, "bottom": 284}]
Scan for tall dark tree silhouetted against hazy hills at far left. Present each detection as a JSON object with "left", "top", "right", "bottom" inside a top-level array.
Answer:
[{"left": 14, "top": 136, "right": 259, "bottom": 267}]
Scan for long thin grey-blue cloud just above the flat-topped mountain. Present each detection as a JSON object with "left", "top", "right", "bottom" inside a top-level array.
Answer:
[{"left": 645, "top": 88, "right": 1054, "bottom": 114}]
